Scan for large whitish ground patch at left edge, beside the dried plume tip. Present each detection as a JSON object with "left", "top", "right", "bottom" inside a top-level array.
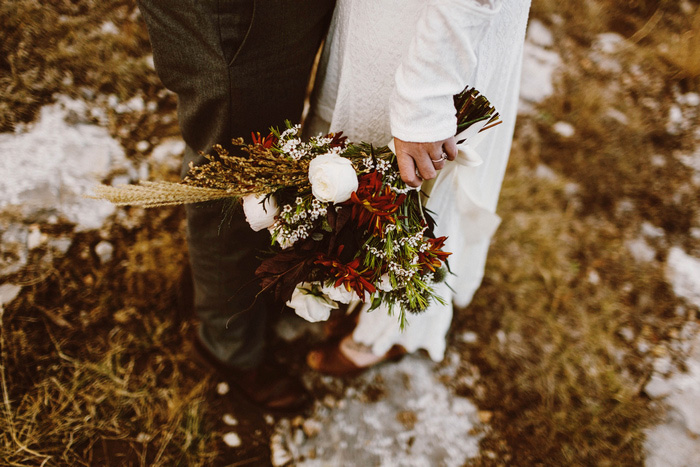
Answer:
[{"left": 0, "top": 97, "right": 133, "bottom": 231}]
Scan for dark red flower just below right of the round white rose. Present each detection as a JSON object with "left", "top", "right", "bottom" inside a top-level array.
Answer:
[{"left": 348, "top": 171, "right": 406, "bottom": 237}]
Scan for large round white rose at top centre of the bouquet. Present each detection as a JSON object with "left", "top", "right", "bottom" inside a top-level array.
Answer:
[{"left": 309, "top": 154, "right": 357, "bottom": 204}]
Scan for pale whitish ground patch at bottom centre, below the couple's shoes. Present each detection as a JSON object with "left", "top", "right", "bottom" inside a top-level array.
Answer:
[{"left": 272, "top": 356, "right": 481, "bottom": 467}]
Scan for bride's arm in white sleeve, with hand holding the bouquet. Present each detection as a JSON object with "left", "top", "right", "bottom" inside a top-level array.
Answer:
[{"left": 390, "top": 0, "right": 500, "bottom": 186}]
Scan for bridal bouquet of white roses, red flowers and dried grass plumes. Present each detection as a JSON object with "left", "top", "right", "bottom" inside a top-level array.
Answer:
[{"left": 96, "top": 88, "right": 500, "bottom": 328}]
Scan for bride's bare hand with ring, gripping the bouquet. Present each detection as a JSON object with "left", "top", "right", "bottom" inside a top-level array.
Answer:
[{"left": 394, "top": 136, "right": 457, "bottom": 187}]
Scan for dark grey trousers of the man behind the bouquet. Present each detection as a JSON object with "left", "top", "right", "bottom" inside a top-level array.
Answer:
[{"left": 139, "top": 0, "right": 334, "bottom": 369}]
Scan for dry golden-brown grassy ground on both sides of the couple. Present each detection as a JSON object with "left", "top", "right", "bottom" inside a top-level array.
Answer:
[{"left": 0, "top": 0, "right": 700, "bottom": 465}]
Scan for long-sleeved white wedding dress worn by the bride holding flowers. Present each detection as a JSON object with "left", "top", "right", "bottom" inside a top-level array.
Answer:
[{"left": 307, "top": 0, "right": 530, "bottom": 361}]
